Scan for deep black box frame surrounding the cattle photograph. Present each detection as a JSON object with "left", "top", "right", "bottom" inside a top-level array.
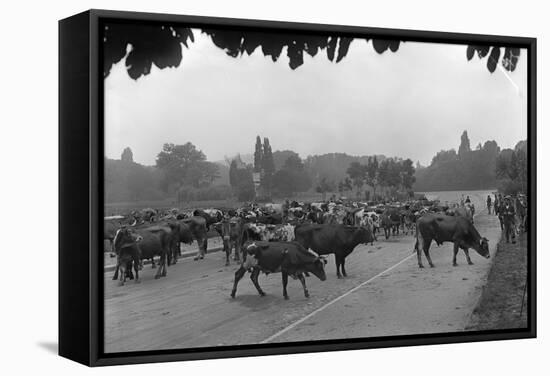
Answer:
[{"left": 59, "top": 10, "right": 537, "bottom": 366}]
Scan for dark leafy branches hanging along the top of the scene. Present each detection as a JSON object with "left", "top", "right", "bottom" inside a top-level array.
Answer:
[{"left": 103, "top": 24, "right": 520, "bottom": 80}]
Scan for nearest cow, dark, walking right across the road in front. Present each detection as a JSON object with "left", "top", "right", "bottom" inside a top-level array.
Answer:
[{"left": 231, "top": 242, "right": 327, "bottom": 300}]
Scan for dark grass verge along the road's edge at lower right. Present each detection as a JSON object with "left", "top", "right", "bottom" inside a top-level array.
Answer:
[{"left": 467, "top": 234, "right": 528, "bottom": 330}]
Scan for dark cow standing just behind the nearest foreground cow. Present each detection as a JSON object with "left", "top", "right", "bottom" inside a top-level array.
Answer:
[{"left": 294, "top": 224, "right": 374, "bottom": 278}]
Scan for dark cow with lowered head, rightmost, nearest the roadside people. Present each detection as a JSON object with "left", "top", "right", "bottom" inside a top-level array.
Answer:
[{"left": 414, "top": 214, "right": 490, "bottom": 268}]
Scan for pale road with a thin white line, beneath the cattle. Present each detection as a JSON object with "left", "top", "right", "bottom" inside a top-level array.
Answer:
[{"left": 104, "top": 203, "right": 500, "bottom": 352}]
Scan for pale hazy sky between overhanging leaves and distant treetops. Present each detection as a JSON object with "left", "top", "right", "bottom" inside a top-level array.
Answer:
[{"left": 105, "top": 30, "right": 527, "bottom": 165}]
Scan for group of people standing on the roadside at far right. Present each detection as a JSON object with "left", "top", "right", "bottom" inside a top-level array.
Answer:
[{"left": 487, "top": 193, "right": 527, "bottom": 243}]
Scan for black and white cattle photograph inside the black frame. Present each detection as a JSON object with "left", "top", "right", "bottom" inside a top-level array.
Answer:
[{"left": 102, "top": 20, "right": 531, "bottom": 354}]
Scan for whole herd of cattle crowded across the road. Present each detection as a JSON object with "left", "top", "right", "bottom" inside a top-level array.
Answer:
[{"left": 104, "top": 200, "right": 489, "bottom": 299}]
